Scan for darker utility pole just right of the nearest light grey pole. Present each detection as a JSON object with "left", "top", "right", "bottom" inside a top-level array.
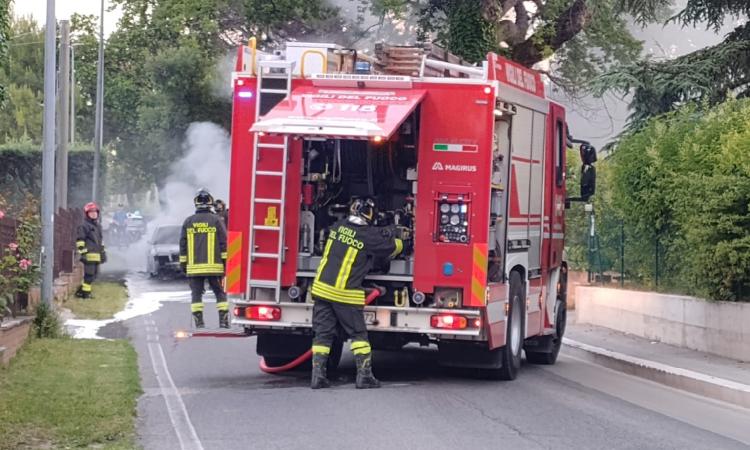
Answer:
[{"left": 55, "top": 20, "right": 70, "bottom": 209}]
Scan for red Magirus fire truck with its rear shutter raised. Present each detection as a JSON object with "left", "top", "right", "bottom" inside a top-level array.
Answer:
[{"left": 227, "top": 43, "right": 595, "bottom": 379}]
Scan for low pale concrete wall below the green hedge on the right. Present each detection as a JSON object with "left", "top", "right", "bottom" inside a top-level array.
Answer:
[{"left": 576, "top": 286, "right": 750, "bottom": 361}]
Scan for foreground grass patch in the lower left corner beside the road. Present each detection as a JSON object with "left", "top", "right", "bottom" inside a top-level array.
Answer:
[{"left": 0, "top": 339, "right": 141, "bottom": 450}]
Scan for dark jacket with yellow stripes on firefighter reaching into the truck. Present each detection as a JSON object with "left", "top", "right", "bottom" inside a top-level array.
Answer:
[{"left": 312, "top": 219, "right": 404, "bottom": 306}]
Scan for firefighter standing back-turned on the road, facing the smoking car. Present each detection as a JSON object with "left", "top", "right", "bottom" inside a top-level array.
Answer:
[{"left": 180, "top": 189, "right": 229, "bottom": 328}]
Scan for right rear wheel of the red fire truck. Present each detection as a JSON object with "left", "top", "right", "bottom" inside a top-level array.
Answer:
[{"left": 488, "top": 271, "right": 526, "bottom": 380}]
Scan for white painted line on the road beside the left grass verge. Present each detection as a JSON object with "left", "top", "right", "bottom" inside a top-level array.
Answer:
[{"left": 147, "top": 324, "right": 203, "bottom": 450}]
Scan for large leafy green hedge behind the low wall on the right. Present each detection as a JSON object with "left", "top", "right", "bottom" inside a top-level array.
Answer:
[{"left": 584, "top": 99, "right": 750, "bottom": 300}]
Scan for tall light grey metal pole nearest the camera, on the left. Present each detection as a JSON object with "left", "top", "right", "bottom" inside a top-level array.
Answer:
[{"left": 41, "top": 0, "right": 57, "bottom": 307}]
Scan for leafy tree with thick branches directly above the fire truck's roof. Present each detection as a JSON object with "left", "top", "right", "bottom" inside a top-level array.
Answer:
[{"left": 364, "top": 0, "right": 671, "bottom": 93}]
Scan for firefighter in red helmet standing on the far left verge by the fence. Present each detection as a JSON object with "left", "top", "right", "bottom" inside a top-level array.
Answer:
[{"left": 76, "top": 202, "right": 107, "bottom": 298}]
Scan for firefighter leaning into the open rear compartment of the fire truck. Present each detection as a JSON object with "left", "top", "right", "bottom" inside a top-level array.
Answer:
[{"left": 310, "top": 198, "right": 412, "bottom": 389}]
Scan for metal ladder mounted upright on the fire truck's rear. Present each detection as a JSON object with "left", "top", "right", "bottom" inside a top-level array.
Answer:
[{"left": 248, "top": 61, "right": 295, "bottom": 303}]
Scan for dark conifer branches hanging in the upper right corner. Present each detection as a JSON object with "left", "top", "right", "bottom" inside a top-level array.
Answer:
[{"left": 595, "top": 0, "right": 750, "bottom": 128}]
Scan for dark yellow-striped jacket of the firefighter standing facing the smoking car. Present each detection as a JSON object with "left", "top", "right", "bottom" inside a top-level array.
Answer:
[{"left": 180, "top": 211, "right": 227, "bottom": 277}]
